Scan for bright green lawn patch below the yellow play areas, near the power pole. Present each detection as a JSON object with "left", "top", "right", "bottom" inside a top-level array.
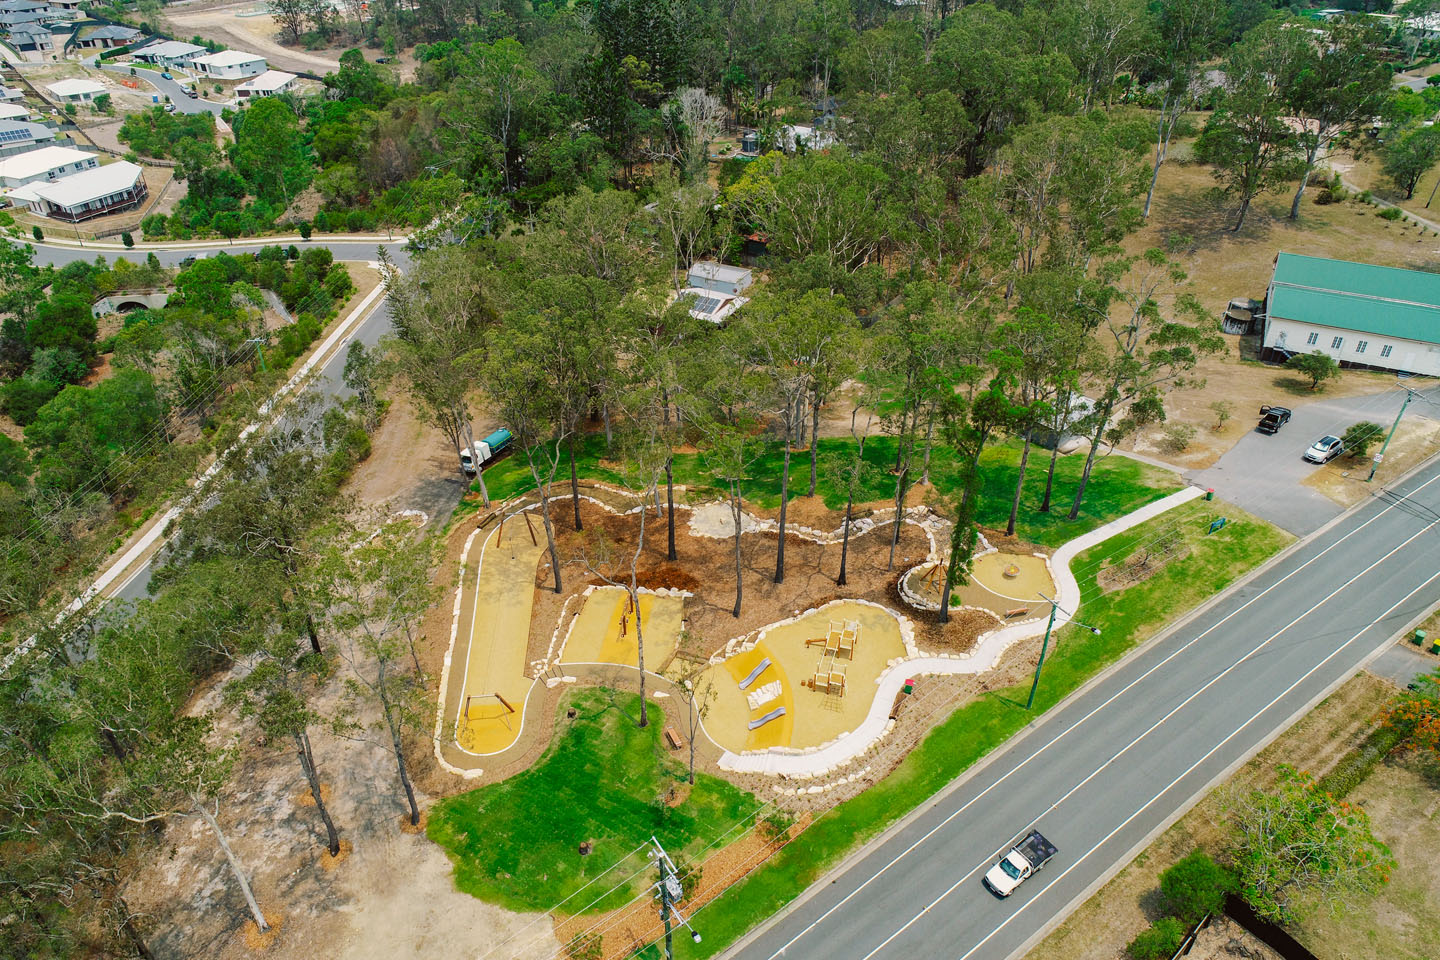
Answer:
[{"left": 428, "top": 689, "right": 759, "bottom": 911}]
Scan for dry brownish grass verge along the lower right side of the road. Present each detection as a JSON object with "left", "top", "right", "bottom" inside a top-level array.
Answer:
[{"left": 1028, "top": 674, "right": 1400, "bottom": 960}]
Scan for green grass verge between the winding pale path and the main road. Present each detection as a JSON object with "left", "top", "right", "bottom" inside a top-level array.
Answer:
[{"left": 675, "top": 502, "right": 1290, "bottom": 957}]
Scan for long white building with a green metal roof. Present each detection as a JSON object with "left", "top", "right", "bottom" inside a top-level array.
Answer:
[{"left": 1260, "top": 253, "right": 1440, "bottom": 376}]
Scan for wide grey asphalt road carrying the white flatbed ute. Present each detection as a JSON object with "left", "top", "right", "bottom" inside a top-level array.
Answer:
[{"left": 737, "top": 463, "right": 1440, "bottom": 960}]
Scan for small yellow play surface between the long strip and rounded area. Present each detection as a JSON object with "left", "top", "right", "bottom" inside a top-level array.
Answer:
[{"left": 560, "top": 587, "right": 684, "bottom": 672}]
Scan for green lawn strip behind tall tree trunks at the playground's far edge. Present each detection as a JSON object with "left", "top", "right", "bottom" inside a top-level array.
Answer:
[{"left": 485, "top": 433, "right": 1181, "bottom": 547}]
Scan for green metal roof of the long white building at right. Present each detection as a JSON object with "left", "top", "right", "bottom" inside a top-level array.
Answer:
[{"left": 1267, "top": 253, "right": 1440, "bottom": 343}]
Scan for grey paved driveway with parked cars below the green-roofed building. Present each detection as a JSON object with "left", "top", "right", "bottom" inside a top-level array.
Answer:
[{"left": 1185, "top": 387, "right": 1440, "bottom": 537}]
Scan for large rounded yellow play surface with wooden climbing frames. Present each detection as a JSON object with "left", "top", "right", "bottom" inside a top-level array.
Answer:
[{"left": 704, "top": 602, "right": 906, "bottom": 753}]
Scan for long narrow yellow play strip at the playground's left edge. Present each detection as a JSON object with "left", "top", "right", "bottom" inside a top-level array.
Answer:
[{"left": 455, "top": 518, "right": 546, "bottom": 754}]
